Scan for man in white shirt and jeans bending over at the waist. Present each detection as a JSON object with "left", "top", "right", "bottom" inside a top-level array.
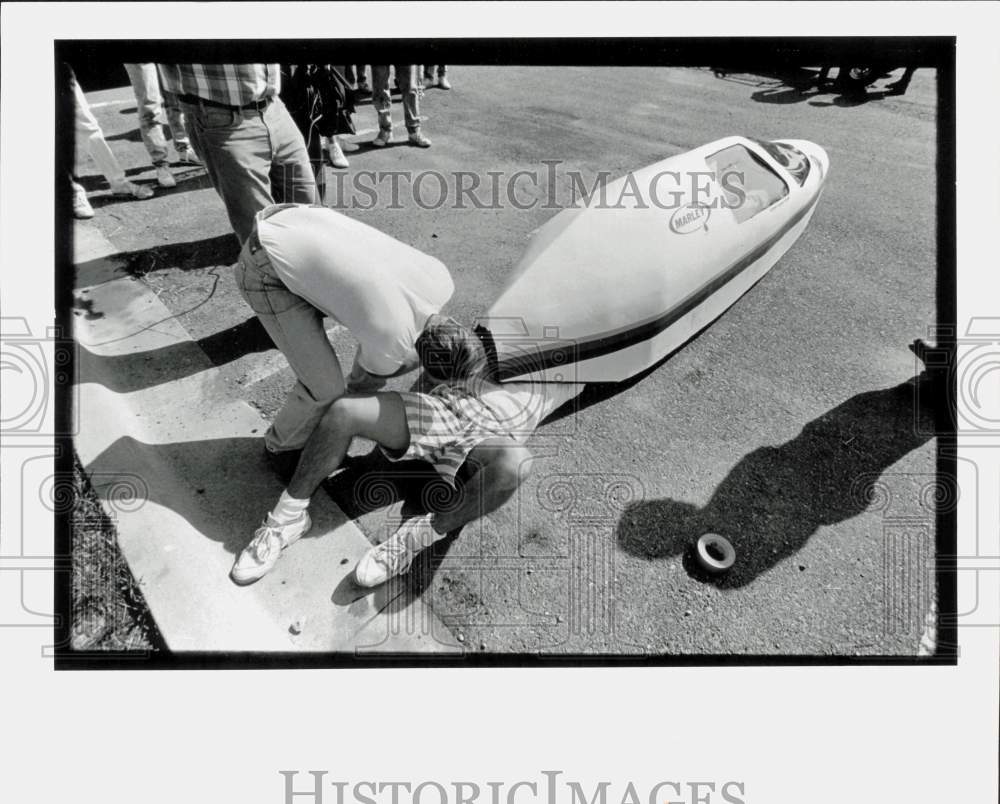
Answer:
[{"left": 234, "top": 204, "right": 454, "bottom": 482}]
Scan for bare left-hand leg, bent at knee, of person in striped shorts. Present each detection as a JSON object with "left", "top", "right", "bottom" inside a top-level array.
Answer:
[{"left": 288, "top": 391, "right": 410, "bottom": 500}]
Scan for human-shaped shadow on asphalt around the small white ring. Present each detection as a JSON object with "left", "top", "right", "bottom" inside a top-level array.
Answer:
[{"left": 616, "top": 371, "right": 938, "bottom": 589}]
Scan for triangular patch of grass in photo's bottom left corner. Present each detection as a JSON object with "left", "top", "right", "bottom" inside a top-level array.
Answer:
[{"left": 70, "top": 454, "right": 167, "bottom": 652}]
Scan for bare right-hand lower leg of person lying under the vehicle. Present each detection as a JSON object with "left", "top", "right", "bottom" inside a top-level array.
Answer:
[{"left": 431, "top": 438, "right": 532, "bottom": 538}]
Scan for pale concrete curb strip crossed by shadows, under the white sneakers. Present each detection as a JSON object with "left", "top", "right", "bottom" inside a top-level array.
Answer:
[{"left": 75, "top": 224, "right": 460, "bottom": 654}]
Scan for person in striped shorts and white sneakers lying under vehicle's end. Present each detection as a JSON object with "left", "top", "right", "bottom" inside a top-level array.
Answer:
[{"left": 231, "top": 314, "right": 583, "bottom": 587}]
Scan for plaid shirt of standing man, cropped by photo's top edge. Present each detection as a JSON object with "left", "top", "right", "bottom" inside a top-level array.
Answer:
[{"left": 157, "top": 64, "right": 281, "bottom": 106}]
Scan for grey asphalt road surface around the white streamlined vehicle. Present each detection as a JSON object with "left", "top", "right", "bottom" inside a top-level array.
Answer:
[{"left": 78, "top": 66, "right": 937, "bottom": 655}]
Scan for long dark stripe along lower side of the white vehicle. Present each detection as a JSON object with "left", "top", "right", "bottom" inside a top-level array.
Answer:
[{"left": 488, "top": 193, "right": 822, "bottom": 381}]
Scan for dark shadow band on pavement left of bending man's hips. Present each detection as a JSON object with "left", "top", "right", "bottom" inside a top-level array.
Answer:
[{"left": 75, "top": 231, "right": 240, "bottom": 288}]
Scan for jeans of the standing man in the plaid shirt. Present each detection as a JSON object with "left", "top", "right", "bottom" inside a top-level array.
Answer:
[{"left": 181, "top": 98, "right": 319, "bottom": 244}]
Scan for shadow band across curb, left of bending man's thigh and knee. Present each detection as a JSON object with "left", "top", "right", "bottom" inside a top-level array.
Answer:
[{"left": 74, "top": 316, "right": 277, "bottom": 394}]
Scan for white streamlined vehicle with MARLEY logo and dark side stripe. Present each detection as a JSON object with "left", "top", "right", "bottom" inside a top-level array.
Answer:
[{"left": 480, "top": 137, "right": 829, "bottom": 382}]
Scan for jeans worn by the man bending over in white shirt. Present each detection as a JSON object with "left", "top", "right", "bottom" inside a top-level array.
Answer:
[{"left": 234, "top": 241, "right": 344, "bottom": 453}]
